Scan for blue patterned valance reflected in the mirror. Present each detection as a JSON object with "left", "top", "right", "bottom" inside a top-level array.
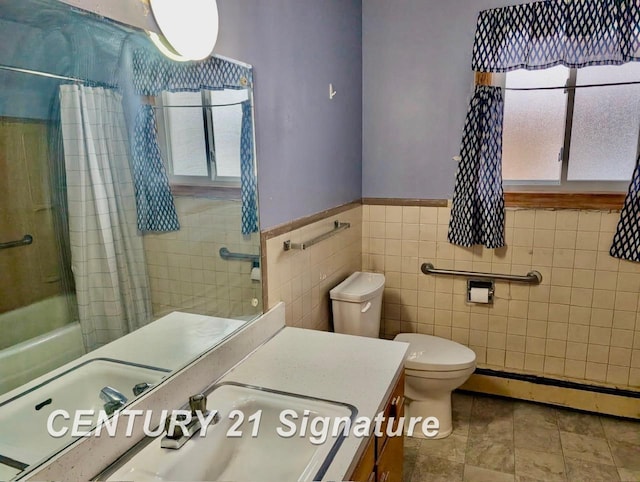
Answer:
[{"left": 133, "top": 50, "right": 253, "bottom": 96}]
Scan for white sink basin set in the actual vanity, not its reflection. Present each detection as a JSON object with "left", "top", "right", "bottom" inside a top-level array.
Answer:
[{"left": 105, "top": 383, "right": 357, "bottom": 481}]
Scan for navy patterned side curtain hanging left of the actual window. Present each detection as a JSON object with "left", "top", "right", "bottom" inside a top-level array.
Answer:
[{"left": 448, "top": 85, "right": 504, "bottom": 248}]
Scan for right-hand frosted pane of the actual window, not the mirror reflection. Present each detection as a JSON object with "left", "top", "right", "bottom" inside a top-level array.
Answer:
[{"left": 567, "top": 62, "right": 640, "bottom": 181}]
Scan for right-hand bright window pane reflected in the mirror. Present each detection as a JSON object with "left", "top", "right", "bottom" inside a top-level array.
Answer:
[{"left": 210, "top": 89, "right": 248, "bottom": 177}]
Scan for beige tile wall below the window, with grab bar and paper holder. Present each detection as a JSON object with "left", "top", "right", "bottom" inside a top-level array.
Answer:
[{"left": 362, "top": 205, "right": 640, "bottom": 389}]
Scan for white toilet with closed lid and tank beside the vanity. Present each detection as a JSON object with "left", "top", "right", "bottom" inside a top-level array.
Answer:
[{"left": 329, "top": 271, "right": 476, "bottom": 438}]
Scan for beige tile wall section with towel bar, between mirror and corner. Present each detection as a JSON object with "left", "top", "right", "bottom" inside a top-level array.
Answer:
[{"left": 266, "top": 206, "right": 362, "bottom": 331}]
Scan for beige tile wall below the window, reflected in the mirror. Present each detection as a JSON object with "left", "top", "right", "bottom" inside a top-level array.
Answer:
[{"left": 144, "top": 197, "right": 262, "bottom": 317}]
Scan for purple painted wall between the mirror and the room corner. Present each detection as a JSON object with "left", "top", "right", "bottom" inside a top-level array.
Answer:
[{"left": 215, "top": 0, "right": 362, "bottom": 230}]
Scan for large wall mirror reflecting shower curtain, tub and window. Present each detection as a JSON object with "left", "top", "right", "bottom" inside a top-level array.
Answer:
[{"left": 0, "top": 0, "right": 262, "bottom": 474}]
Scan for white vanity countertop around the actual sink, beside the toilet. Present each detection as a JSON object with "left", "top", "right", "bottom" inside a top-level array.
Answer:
[{"left": 218, "top": 327, "right": 409, "bottom": 480}]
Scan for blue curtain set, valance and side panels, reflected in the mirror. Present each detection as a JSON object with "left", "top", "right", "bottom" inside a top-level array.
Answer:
[{"left": 132, "top": 49, "right": 258, "bottom": 233}]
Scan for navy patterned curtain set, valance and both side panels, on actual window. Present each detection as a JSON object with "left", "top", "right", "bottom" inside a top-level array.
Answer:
[{"left": 449, "top": 0, "right": 640, "bottom": 252}]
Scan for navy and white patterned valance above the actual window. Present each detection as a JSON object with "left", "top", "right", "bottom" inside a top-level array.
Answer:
[{"left": 471, "top": 0, "right": 640, "bottom": 72}]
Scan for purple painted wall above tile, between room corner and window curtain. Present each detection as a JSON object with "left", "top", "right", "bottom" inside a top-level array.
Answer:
[{"left": 362, "top": 0, "right": 522, "bottom": 199}]
